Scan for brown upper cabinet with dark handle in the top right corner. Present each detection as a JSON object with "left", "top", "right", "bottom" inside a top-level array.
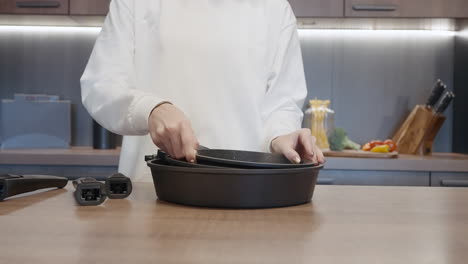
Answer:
[{"left": 345, "top": 0, "right": 468, "bottom": 18}]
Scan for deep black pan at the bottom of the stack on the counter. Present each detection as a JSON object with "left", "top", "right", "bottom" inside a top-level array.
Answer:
[{"left": 147, "top": 158, "right": 323, "bottom": 208}]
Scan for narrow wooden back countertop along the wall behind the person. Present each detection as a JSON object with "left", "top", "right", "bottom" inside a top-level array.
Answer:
[{"left": 0, "top": 147, "right": 468, "bottom": 172}]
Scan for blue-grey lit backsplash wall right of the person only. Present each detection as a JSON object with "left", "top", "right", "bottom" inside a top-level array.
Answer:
[{"left": 299, "top": 30, "right": 455, "bottom": 152}]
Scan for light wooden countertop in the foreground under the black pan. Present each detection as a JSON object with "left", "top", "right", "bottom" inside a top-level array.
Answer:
[{"left": 0, "top": 183, "right": 468, "bottom": 264}]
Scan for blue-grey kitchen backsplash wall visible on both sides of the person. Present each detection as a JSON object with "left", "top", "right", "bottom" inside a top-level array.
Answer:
[{"left": 0, "top": 27, "right": 454, "bottom": 151}]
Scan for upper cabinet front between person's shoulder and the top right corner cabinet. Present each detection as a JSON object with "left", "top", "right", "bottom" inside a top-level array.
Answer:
[{"left": 289, "top": 0, "right": 344, "bottom": 17}]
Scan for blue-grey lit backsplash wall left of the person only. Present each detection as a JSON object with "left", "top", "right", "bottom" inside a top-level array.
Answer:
[{"left": 0, "top": 26, "right": 99, "bottom": 146}]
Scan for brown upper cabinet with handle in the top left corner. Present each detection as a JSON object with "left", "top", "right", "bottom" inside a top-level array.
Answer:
[{"left": 0, "top": 0, "right": 69, "bottom": 15}]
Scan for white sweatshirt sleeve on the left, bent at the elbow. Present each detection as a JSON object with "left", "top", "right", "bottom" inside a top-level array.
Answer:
[{"left": 81, "top": 0, "right": 163, "bottom": 135}]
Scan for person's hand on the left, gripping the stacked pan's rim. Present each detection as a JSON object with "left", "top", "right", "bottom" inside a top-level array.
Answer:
[{"left": 148, "top": 103, "right": 198, "bottom": 163}]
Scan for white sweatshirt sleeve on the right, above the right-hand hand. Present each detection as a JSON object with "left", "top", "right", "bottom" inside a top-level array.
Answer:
[{"left": 262, "top": 12, "right": 307, "bottom": 151}]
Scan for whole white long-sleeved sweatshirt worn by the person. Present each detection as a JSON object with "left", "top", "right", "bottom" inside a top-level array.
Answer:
[{"left": 81, "top": 0, "right": 307, "bottom": 181}]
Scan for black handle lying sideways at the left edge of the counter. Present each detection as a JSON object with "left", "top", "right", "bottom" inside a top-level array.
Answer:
[{"left": 0, "top": 174, "right": 68, "bottom": 201}]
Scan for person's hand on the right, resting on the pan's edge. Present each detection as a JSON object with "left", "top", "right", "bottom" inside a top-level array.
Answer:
[{"left": 271, "top": 128, "right": 325, "bottom": 164}]
